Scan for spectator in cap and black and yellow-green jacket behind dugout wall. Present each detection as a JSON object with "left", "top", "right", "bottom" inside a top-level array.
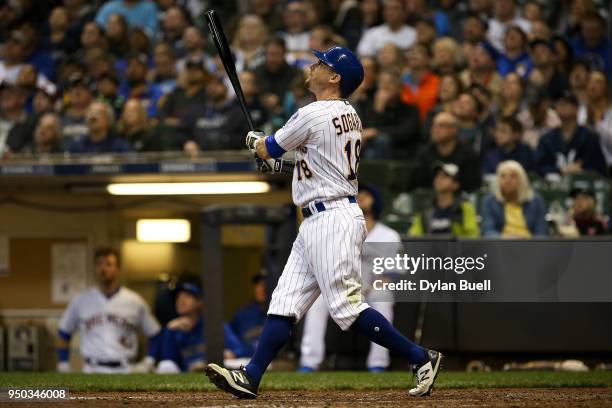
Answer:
[{"left": 408, "top": 162, "right": 480, "bottom": 237}]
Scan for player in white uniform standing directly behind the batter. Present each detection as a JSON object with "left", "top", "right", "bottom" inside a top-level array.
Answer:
[{"left": 298, "top": 185, "right": 401, "bottom": 372}]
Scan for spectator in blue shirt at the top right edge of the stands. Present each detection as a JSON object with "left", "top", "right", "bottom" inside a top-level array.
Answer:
[{"left": 572, "top": 12, "right": 612, "bottom": 78}]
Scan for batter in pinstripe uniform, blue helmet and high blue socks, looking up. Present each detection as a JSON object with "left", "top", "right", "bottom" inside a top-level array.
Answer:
[{"left": 206, "top": 47, "right": 441, "bottom": 398}]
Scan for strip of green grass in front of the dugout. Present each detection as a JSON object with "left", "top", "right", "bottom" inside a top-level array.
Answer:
[{"left": 0, "top": 371, "right": 612, "bottom": 392}]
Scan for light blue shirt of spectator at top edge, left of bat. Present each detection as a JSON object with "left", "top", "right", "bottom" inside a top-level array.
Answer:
[{"left": 96, "top": 0, "right": 158, "bottom": 38}]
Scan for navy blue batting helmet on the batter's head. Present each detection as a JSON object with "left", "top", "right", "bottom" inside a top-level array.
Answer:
[{"left": 312, "top": 46, "right": 363, "bottom": 98}]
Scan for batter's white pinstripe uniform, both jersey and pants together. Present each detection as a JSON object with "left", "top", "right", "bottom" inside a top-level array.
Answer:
[{"left": 268, "top": 100, "right": 369, "bottom": 330}]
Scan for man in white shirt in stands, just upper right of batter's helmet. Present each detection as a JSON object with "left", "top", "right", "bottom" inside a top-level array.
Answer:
[{"left": 357, "top": 0, "right": 416, "bottom": 57}]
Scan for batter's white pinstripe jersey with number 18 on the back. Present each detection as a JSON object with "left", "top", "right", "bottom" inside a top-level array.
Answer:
[{"left": 274, "top": 100, "right": 361, "bottom": 207}]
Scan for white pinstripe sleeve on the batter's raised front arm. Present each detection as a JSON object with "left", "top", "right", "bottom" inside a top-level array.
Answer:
[{"left": 274, "top": 105, "right": 327, "bottom": 151}]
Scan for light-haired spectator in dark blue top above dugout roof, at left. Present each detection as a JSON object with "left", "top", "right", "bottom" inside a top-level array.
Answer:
[{"left": 68, "top": 101, "right": 130, "bottom": 153}]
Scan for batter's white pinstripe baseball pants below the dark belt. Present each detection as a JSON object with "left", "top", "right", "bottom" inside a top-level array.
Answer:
[{"left": 268, "top": 198, "right": 369, "bottom": 330}]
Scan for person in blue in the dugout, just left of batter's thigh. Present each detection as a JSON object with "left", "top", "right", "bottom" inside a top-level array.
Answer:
[{"left": 230, "top": 273, "right": 267, "bottom": 356}]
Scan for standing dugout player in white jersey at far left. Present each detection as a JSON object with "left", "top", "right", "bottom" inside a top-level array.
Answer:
[{"left": 57, "top": 249, "right": 160, "bottom": 373}]
